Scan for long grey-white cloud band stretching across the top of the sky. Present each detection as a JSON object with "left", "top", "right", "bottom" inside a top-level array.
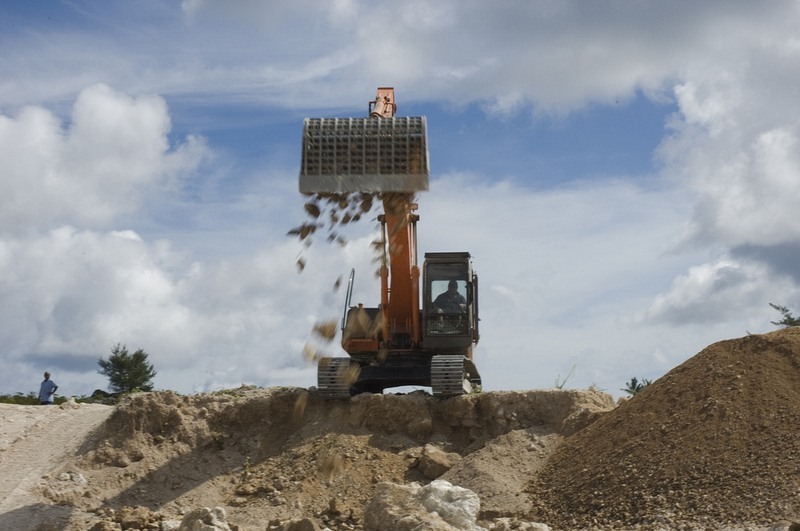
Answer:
[{"left": 0, "top": 0, "right": 796, "bottom": 113}]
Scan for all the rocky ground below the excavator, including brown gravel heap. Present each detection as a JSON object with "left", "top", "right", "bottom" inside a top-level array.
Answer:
[{"left": 0, "top": 328, "right": 800, "bottom": 531}]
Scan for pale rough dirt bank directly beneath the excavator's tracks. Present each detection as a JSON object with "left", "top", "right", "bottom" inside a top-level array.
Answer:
[{"left": 31, "top": 388, "right": 614, "bottom": 530}]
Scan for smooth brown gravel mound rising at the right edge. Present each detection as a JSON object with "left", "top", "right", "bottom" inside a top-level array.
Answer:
[{"left": 530, "top": 328, "right": 800, "bottom": 529}]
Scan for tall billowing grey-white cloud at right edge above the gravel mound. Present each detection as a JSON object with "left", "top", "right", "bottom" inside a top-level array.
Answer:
[{"left": 647, "top": 6, "right": 800, "bottom": 325}]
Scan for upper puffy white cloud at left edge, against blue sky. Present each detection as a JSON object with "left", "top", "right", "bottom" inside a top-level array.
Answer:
[{"left": 0, "top": 85, "right": 206, "bottom": 233}]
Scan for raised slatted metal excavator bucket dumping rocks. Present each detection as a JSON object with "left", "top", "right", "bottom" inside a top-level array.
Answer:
[{"left": 300, "top": 117, "right": 429, "bottom": 193}]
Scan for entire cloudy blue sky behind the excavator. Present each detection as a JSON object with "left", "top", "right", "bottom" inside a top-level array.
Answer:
[{"left": 0, "top": 0, "right": 800, "bottom": 396}]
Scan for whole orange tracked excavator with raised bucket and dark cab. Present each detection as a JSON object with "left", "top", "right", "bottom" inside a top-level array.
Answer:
[{"left": 300, "top": 87, "right": 481, "bottom": 398}]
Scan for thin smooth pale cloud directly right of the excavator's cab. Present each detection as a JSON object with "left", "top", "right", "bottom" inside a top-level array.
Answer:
[{"left": 418, "top": 175, "right": 712, "bottom": 393}]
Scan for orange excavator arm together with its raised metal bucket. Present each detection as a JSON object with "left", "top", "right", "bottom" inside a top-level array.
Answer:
[{"left": 300, "top": 87, "right": 429, "bottom": 348}]
